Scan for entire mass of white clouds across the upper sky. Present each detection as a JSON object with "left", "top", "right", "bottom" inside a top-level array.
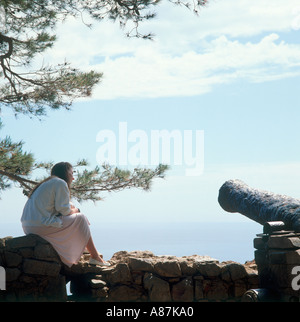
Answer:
[{"left": 41, "top": 0, "right": 300, "bottom": 99}]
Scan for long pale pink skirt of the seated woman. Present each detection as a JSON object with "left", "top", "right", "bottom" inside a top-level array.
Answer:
[{"left": 23, "top": 213, "right": 91, "bottom": 267}]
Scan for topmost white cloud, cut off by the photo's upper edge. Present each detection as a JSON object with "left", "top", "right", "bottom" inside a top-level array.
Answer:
[{"left": 144, "top": 0, "right": 300, "bottom": 46}]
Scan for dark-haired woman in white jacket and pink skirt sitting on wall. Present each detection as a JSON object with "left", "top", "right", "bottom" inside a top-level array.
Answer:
[{"left": 21, "top": 162, "right": 109, "bottom": 267}]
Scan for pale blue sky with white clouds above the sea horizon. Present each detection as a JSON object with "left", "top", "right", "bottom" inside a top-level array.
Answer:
[{"left": 0, "top": 0, "right": 300, "bottom": 239}]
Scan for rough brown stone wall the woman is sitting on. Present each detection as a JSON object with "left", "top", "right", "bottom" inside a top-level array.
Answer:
[{"left": 0, "top": 235, "right": 258, "bottom": 302}]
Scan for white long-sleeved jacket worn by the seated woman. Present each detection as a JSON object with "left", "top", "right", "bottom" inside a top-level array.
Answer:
[{"left": 21, "top": 177, "right": 71, "bottom": 227}]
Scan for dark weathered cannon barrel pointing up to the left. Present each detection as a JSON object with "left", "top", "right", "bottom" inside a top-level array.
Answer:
[{"left": 218, "top": 180, "right": 300, "bottom": 232}]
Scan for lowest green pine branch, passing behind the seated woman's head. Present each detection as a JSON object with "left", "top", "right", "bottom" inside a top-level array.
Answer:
[{"left": 0, "top": 138, "right": 168, "bottom": 202}]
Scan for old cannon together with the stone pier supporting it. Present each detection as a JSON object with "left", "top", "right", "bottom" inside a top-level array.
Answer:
[{"left": 218, "top": 180, "right": 300, "bottom": 302}]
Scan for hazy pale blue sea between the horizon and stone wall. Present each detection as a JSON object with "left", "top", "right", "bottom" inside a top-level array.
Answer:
[{"left": 0, "top": 220, "right": 262, "bottom": 264}]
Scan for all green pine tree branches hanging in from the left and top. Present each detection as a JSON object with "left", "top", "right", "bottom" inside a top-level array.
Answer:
[{"left": 0, "top": 0, "right": 206, "bottom": 200}]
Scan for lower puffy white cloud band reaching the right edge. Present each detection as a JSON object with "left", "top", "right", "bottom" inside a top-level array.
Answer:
[{"left": 88, "top": 34, "right": 300, "bottom": 99}]
